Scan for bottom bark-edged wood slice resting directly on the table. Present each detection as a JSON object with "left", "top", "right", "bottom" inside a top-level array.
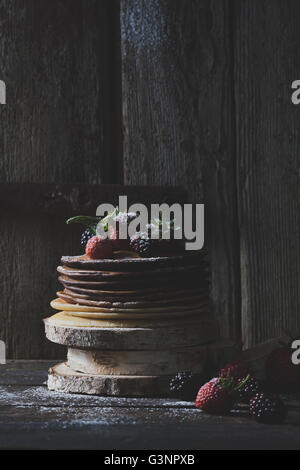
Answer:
[{"left": 48, "top": 363, "right": 177, "bottom": 398}]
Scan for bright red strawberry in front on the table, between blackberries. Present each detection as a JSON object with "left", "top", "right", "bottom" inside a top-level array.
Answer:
[{"left": 195, "top": 375, "right": 250, "bottom": 414}]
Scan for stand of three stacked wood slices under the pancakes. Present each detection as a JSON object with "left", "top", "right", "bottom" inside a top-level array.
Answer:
[{"left": 44, "top": 312, "right": 235, "bottom": 397}]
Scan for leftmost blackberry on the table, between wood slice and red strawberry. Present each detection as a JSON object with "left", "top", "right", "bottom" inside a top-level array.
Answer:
[{"left": 170, "top": 371, "right": 201, "bottom": 401}]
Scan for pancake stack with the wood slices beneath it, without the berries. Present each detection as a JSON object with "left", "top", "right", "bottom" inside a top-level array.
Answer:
[{"left": 44, "top": 251, "right": 216, "bottom": 396}]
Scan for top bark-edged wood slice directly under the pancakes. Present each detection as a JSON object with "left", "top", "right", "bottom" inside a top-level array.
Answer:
[{"left": 44, "top": 315, "right": 216, "bottom": 351}]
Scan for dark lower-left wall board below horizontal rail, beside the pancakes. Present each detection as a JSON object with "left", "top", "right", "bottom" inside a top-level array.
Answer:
[{"left": 0, "top": 215, "right": 75, "bottom": 359}]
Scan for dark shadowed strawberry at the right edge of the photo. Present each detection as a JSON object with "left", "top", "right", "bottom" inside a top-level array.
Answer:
[{"left": 265, "top": 346, "right": 300, "bottom": 391}]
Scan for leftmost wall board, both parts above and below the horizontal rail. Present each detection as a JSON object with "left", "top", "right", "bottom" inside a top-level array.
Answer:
[{"left": 0, "top": 0, "right": 121, "bottom": 359}]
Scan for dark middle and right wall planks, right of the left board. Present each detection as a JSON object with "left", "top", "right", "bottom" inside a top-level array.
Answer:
[{"left": 121, "top": 0, "right": 300, "bottom": 347}]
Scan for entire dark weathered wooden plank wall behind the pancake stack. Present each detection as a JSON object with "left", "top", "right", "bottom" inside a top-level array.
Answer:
[{"left": 0, "top": 0, "right": 300, "bottom": 359}]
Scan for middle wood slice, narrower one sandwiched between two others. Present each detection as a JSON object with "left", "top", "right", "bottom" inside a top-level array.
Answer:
[{"left": 68, "top": 346, "right": 208, "bottom": 376}]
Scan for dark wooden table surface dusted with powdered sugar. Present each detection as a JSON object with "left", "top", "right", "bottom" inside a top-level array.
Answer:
[{"left": 0, "top": 361, "right": 300, "bottom": 450}]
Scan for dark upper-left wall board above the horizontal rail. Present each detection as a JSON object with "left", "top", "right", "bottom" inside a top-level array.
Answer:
[{"left": 0, "top": 0, "right": 118, "bottom": 183}]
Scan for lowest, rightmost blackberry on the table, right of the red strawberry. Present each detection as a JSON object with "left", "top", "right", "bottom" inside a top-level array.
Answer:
[{"left": 250, "top": 393, "right": 286, "bottom": 424}]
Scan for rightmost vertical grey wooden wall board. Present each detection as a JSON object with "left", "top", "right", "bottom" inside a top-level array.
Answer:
[{"left": 234, "top": 0, "right": 300, "bottom": 347}]
